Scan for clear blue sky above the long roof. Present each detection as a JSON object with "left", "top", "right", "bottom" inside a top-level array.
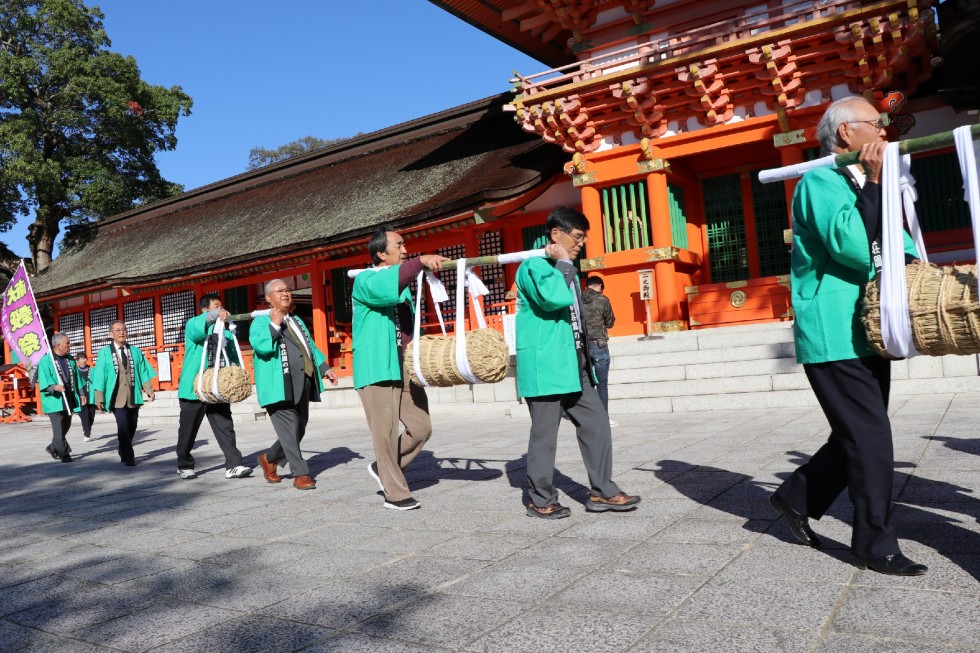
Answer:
[{"left": 2, "top": 0, "right": 547, "bottom": 256}]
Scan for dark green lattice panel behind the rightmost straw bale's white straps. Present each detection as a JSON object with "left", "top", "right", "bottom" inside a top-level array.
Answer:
[{"left": 912, "top": 152, "right": 970, "bottom": 233}]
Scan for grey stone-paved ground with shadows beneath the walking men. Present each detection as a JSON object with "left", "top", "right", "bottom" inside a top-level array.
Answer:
[{"left": 0, "top": 394, "right": 980, "bottom": 653}]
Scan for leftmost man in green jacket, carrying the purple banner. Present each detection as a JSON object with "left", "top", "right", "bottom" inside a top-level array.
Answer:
[{"left": 37, "top": 333, "right": 86, "bottom": 463}]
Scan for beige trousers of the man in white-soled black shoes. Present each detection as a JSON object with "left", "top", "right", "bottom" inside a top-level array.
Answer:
[{"left": 357, "top": 370, "right": 432, "bottom": 501}]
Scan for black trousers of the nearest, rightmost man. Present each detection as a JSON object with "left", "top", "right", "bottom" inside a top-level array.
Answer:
[{"left": 776, "top": 356, "right": 900, "bottom": 559}]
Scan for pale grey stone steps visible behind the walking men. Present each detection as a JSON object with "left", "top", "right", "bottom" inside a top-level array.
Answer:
[{"left": 132, "top": 322, "right": 980, "bottom": 425}]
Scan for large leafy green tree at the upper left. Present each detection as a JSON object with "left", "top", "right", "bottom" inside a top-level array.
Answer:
[{"left": 0, "top": 0, "right": 192, "bottom": 272}]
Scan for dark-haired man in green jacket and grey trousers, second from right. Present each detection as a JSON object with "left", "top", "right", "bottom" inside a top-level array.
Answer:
[{"left": 515, "top": 207, "right": 640, "bottom": 519}]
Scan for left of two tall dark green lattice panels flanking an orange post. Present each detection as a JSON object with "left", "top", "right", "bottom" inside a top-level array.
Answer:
[{"left": 701, "top": 173, "right": 749, "bottom": 283}]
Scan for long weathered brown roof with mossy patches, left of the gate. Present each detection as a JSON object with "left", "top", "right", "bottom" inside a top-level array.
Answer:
[{"left": 33, "top": 95, "right": 565, "bottom": 297}]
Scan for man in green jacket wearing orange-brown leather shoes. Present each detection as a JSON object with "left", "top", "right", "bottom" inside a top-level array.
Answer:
[{"left": 248, "top": 279, "right": 337, "bottom": 490}]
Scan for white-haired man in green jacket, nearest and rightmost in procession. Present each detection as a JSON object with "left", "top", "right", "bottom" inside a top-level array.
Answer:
[{"left": 770, "top": 97, "right": 927, "bottom": 576}]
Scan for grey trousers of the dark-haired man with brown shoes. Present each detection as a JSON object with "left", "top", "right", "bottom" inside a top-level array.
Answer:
[{"left": 526, "top": 370, "right": 621, "bottom": 508}]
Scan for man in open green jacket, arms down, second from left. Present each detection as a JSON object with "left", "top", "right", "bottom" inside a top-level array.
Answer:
[{"left": 92, "top": 320, "right": 157, "bottom": 467}]
